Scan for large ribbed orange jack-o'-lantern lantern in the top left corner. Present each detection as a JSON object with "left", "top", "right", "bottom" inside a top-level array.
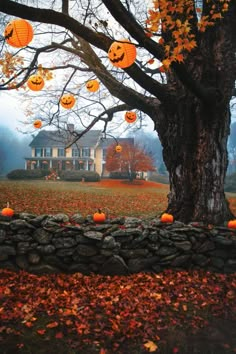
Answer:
[{"left": 4, "top": 19, "right": 33, "bottom": 48}]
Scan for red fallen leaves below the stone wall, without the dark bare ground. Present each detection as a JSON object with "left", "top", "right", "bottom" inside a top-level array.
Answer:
[{"left": 0, "top": 270, "right": 236, "bottom": 353}]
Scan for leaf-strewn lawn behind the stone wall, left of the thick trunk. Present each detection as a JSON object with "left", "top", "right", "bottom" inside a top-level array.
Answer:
[{"left": 0, "top": 180, "right": 168, "bottom": 217}]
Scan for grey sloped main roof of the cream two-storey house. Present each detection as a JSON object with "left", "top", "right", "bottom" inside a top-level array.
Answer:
[{"left": 29, "top": 130, "right": 101, "bottom": 148}]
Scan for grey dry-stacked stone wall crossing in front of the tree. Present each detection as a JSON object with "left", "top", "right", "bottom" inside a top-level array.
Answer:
[{"left": 0, "top": 213, "right": 236, "bottom": 275}]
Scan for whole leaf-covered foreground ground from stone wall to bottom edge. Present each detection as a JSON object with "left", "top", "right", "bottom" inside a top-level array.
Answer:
[{"left": 0, "top": 270, "right": 236, "bottom": 354}]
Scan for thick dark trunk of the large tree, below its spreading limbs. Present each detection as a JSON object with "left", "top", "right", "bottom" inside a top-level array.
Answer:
[{"left": 157, "top": 94, "right": 232, "bottom": 224}]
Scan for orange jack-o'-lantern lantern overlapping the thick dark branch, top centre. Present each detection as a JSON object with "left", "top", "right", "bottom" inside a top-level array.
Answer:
[{"left": 108, "top": 39, "right": 136, "bottom": 69}]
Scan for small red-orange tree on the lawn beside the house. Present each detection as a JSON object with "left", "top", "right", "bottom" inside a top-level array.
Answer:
[{"left": 106, "top": 143, "right": 155, "bottom": 181}]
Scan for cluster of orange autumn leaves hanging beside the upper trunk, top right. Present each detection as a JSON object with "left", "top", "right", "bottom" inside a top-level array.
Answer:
[{"left": 146, "top": 0, "right": 232, "bottom": 69}]
